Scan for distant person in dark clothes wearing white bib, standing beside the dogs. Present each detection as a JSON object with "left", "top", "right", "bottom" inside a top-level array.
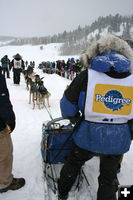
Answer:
[{"left": 10, "top": 53, "right": 25, "bottom": 84}]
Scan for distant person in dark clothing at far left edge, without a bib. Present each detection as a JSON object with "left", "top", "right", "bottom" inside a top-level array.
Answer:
[{"left": 1, "top": 55, "right": 10, "bottom": 78}]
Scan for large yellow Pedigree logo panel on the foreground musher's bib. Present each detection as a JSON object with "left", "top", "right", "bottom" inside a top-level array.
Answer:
[{"left": 92, "top": 84, "right": 133, "bottom": 115}]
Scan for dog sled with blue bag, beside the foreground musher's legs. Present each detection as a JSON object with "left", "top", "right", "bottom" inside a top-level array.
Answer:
[{"left": 41, "top": 117, "right": 89, "bottom": 200}]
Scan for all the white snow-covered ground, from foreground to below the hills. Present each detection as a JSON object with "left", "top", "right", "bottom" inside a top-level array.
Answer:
[{"left": 0, "top": 44, "right": 133, "bottom": 200}]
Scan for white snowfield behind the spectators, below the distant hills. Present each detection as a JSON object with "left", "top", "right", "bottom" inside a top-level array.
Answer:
[{"left": 0, "top": 43, "right": 78, "bottom": 66}]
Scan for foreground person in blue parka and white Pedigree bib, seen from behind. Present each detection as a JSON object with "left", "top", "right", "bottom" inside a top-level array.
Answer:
[{"left": 58, "top": 34, "right": 133, "bottom": 200}]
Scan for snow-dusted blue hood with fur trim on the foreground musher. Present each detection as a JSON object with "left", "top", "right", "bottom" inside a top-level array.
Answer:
[{"left": 81, "top": 33, "right": 133, "bottom": 73}]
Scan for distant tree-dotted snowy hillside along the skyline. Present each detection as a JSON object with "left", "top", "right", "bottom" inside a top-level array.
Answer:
[{"left": 0, "top": 14, "right": 133, "bottom": 55}]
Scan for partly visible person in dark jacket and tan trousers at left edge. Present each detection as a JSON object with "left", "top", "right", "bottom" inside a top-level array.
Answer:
[{"left": 0, "top": 73, "right": 25, "bottom": 193}]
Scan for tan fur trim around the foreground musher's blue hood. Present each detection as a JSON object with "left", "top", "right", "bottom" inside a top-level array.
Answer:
[{"left": 81, "top": 33, "right": 133, "bottom": 73}]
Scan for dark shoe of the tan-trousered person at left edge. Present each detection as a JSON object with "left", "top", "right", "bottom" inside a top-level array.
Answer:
[{"left": 0, "top": 178, "right": 25, "bottom": 193}]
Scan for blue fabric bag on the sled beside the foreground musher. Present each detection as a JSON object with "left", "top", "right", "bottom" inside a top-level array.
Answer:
[{"left": 41, "top": 118, "right": 74, "bottom": 164}]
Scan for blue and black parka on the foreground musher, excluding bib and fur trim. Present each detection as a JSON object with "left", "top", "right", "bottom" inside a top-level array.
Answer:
[{"left": 60, "top": 34, "right": 131, "bottom": 154}]
